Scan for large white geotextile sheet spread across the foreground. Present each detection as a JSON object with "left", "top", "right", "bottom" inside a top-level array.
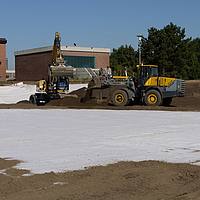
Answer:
[{"left": 0, "top": 109, "right": 200, "bottom": 173}]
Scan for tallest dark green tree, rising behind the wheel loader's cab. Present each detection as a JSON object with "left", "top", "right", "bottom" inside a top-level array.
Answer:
[{"left": 141, "top": 23, "right": 191, "bottom": 79}]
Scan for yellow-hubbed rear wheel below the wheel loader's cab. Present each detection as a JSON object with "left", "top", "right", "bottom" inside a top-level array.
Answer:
[{"left": 144, "top": 90, "right": 162, "bottom": 106}]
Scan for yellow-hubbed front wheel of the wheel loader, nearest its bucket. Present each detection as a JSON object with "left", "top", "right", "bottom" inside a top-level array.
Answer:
[{"left": 112, "top": 90, "right": 128, "bottom": 106}]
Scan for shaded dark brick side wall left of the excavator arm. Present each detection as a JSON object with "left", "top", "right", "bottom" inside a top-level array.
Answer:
[{"left": 15, "top": 51, "right": 52, "bottom": 81}]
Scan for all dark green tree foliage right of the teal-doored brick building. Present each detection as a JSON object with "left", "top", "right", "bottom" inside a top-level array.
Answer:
[{"left": 110, "top": 23, "right": 200, "bottom": 80}]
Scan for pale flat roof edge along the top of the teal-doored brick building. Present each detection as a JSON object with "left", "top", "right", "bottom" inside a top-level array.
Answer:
[{"left": 14, "top": 46, "right": 110, "bottom": 56}]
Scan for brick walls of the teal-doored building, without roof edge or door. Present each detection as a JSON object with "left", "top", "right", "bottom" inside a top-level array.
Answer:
[{"left": 15, "top": 47, "right": 110, "bottom": 81}]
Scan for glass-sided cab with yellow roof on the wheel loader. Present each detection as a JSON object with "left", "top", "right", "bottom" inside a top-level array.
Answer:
[{"left": 137, "top": 65, "right": 158, "bottom": 86}]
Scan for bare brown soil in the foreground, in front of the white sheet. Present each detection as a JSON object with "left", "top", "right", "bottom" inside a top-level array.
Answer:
[{"left": 0, "top": 159, "right": 200, "bottom": 200}]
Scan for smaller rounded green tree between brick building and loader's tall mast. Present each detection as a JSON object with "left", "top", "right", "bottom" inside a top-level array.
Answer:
[{"left": 110, "top": 44, "right": 138, "bottom": 75}]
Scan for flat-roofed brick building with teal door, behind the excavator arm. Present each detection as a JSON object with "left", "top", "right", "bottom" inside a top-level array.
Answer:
[{"left": 14, "top": 46, "right": 110, "bottom": 81}]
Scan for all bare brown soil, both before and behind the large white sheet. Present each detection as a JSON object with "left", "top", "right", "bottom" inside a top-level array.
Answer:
[{"left": 0, "top": 80, "right": 200, "bottom": 200}]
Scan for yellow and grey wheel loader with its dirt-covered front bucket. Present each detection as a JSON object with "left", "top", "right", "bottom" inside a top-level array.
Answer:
[{"left": 85, "top": 65, "right": 186, "bottom": 106}]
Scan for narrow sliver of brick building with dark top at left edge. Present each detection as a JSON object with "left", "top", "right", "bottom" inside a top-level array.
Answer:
[{"left": 0, "top": 38, "right": 7, "bottom": 80}]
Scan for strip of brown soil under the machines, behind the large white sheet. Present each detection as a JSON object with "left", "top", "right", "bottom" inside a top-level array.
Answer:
[{"left": 0, "top": 80, "right": 200, "bottom": 111}]
